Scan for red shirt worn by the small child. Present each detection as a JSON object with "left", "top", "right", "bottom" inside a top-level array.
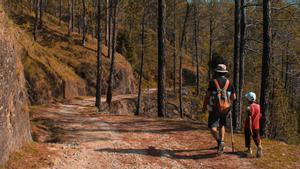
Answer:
[{"left": 244, "top": 103, "right": 260, "bottom": 129}]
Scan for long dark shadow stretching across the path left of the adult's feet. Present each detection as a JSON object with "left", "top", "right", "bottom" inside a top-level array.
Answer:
[{"left": 95, "top": 146, "right": 218, "bottom": 160}]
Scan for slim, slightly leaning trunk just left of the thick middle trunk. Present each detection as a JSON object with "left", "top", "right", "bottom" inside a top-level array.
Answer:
[{"left": 135, "top": 9, "right": 146, "bottom": 115}]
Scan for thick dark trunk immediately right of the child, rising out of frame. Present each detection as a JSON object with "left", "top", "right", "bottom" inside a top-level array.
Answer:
[{"left": 260, "top": 0, "right": 272, "bottom": 135}]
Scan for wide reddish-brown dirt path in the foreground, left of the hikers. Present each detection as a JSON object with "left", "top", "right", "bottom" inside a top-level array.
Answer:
[{"left": 32, "top": 99, "right": 253, "bottom": 169}]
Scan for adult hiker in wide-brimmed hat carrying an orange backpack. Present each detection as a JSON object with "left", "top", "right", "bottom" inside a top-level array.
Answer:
[{"left": 202, "top": 64, "right": 236, "bottom": 154}]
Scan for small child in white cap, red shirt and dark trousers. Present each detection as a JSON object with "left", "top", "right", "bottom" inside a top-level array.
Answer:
[{"left": 244, "top": 92, "right": 262, "bottom": 158}]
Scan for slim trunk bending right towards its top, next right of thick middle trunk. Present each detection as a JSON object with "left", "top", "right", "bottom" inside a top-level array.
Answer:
[{"left": 179, "top": 3, "right": 190, "bottom": 118}]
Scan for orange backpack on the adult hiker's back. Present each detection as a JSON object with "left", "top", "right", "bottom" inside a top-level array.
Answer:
[{"left": 214, "top": 79, "right": 231, "bottom": 114}]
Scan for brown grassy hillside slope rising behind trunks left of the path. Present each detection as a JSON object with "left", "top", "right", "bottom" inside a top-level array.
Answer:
[{"left": 7, "top": 10, "right": 136, "bottom": 104}]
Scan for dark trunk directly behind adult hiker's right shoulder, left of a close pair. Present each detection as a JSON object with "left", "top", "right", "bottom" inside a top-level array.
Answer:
[{"left": 232, "top": 0, "right": 241, "bottom": 128}]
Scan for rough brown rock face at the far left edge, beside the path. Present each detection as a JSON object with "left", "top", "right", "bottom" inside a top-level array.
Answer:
[{"left": 0, "top": 8, "right": 31, "bottom": 165}]
